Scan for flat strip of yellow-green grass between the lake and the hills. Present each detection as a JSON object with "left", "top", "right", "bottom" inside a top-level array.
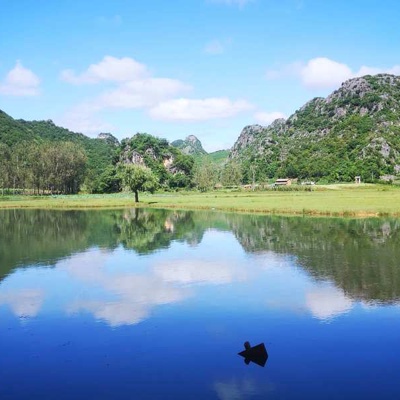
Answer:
[{"left": 0, "top": 185, "right": 400, "bottom": 217}]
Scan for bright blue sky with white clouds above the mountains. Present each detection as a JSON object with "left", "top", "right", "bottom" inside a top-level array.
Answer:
[{"left": 0, "top": 0, "right": 400, "bottom": 151}]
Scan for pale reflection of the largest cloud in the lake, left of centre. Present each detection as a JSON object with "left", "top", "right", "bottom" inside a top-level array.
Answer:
[{"left": 62, "top": 251, "right": 187, "bottom": 326}]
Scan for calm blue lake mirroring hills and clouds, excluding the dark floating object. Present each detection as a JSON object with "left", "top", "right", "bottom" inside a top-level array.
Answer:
[{"left": 0, "top": 210, "right": 400, "bottom": 400}]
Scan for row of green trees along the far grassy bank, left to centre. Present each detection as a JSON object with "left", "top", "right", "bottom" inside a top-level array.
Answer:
[{"left": 0, "top": 142, "right": 243, "bottom": 201}]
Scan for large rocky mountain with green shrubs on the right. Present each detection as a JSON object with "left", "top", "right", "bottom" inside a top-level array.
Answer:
[{"left": 229, "top": 74, "right": 400, "bottom": 181}]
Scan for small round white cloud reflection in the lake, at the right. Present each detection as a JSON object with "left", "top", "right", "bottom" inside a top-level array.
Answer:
[{"left": 306, "top": 287, "right": 353, "bottom": 320}]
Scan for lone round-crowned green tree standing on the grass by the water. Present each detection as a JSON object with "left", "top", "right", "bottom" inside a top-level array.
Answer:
[{"left": 119, "top": 164, "right": 158, "bottom": 203}]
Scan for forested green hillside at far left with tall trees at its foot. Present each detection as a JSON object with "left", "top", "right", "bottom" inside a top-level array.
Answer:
[{"left": 0, "top": 111, "right": 119, "bottom": 193}]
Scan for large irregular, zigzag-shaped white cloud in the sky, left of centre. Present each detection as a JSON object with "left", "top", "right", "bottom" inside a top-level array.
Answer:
[{"left": 60, "top": 56, "right": 191, "bottom": 134}]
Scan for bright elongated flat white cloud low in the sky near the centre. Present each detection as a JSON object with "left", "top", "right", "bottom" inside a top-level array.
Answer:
[{"left": 149, "top": 97, "right": 253, "bottom": 121}]
